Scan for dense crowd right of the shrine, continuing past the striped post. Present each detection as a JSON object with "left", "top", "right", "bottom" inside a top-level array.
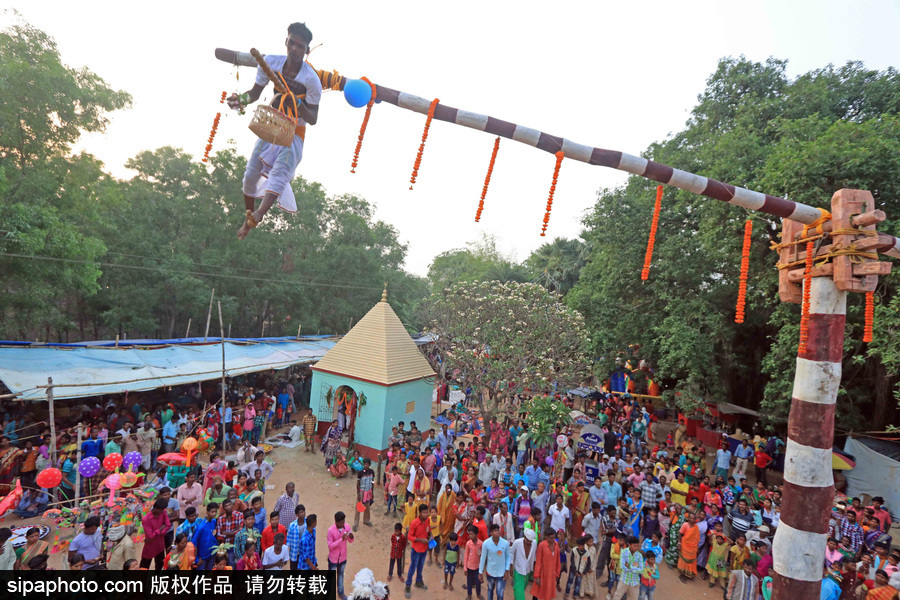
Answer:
[{"left": 361, "top": 395, "right": 900, "bottom": 600}]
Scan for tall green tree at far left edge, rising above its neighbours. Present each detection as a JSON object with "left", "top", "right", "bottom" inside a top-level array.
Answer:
[{"left": 0, "top": 23, "right": 131, "bottom": 339}]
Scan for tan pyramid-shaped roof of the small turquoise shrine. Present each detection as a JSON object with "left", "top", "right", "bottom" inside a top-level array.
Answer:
[{"left": 313, "top": 292, "right": 434, "bottom": 385}]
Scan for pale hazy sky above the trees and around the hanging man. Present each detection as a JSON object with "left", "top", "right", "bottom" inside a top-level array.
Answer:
[{"left": 7, "top": 0, "right": 900, "bottom": 275}]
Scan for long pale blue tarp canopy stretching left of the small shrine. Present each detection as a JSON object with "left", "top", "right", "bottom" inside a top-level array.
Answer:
[{"left": 0, "top": 339, "right": 336, "bottom": 400}]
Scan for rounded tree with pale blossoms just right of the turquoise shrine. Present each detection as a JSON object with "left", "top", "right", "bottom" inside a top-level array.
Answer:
[{"left": 424, "top": 281, "right": 591, "bottom": 417}]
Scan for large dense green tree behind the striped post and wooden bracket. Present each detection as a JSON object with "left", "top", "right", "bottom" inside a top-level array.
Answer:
[{"left": 566, "top": 57, "right": 900, "bottom": 429}]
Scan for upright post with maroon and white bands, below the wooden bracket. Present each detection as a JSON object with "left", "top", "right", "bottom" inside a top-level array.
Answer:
[{"left": 772, "top": 277, "right": 847, "bottom": 600}]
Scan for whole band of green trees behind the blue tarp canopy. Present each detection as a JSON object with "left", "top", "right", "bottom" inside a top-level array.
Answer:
[{"left": 0, "top": 25, "right": 427, "bottom": 341}]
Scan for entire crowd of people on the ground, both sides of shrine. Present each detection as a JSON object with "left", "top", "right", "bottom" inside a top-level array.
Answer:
[{"left": 0, "top": 381, "right": 900, "bottom": 600}]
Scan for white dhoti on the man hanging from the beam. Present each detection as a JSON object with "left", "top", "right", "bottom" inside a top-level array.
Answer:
[{"left": 243, "top": 135, "right": 303, "bottom": 213}]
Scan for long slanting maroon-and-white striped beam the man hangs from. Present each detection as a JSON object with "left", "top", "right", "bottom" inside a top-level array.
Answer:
[{"left": 215, "top": 48, "right": 900, "bottom": 258}]
